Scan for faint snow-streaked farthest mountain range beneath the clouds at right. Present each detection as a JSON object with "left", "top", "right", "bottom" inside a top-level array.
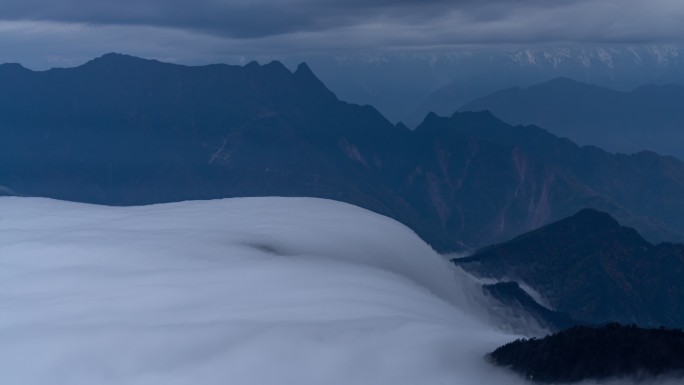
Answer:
[{"left": 285, "top": 45, "right": 684, "bottom": 125}]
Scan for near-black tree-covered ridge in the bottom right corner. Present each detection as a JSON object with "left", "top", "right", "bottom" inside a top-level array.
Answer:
[{"left": 488, "top": 323, "right": 684, "bottom": 383}]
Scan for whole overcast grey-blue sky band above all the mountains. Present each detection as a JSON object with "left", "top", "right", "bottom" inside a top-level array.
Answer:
[{"left": 0, "top": 0, "right": 684, "bottom": 68}]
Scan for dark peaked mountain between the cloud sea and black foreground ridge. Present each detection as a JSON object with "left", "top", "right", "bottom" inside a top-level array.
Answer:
[{"left": 454, "top": 209, "right": 684, "bottom": 327}]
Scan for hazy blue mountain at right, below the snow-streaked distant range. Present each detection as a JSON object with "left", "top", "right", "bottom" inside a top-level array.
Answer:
[{"left": 461, "top": 78, "right": 684, "bottom": 159}]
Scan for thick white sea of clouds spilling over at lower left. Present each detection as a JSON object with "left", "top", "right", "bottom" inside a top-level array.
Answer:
[{"left": 0, "top": 197, "right": 672, "bottom": 385}]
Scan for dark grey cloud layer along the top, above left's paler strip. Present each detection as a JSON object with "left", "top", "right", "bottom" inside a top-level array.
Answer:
[{"left": 0, "top": 0, "right": 684, "bottom": 57}]
